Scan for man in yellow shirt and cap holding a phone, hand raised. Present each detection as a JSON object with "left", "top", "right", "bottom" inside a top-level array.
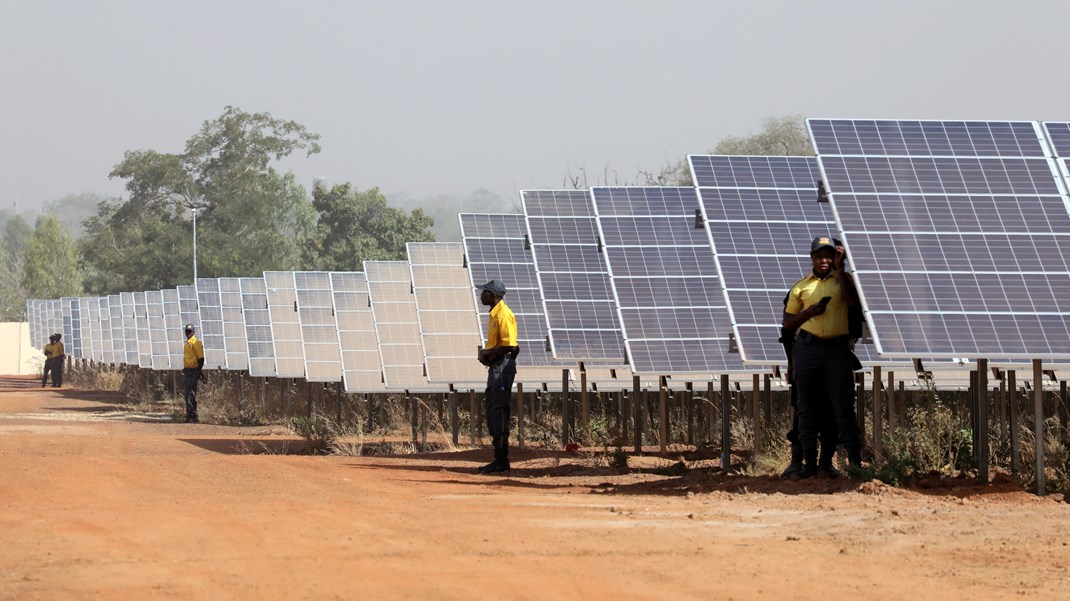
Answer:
[{"left": 782, "top": 236, "right": 861, "bottom": 478}]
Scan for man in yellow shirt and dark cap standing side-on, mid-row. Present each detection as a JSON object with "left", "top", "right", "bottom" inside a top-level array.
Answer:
[{"left": 478, "top": 279, "right": 520, "bottom": 474}]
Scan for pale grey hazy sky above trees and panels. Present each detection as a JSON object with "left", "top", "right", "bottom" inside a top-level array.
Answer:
[{"left": 0, "top": 0, "right": 1070, "bottom": 209}]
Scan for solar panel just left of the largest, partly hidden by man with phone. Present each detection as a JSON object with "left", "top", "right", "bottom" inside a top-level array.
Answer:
[{"left": 688, "top": 155, "right": 836, "bottom": 365}]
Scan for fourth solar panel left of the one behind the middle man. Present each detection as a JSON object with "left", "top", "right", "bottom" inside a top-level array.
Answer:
[{"left": 293, "top": 272, "right": 341, "bottom": 382}]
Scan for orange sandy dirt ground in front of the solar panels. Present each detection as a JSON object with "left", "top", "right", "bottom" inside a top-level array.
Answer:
[{"left": 0, "top": 376, "right": 1070, "bottom": 600}]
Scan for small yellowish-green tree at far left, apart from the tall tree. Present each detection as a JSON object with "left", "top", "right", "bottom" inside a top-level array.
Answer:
[{"left": 21, "top": 213, "right": 82, "bottom": 303}]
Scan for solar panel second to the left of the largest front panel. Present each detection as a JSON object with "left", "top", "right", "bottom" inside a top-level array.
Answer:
[{"left": 591, "top": 187, "right": 743, "bottom": 375}]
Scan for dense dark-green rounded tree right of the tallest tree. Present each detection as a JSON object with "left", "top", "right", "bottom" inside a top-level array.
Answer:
[{"left": 305, "top": 183, "right": 434, "bottom": 272}]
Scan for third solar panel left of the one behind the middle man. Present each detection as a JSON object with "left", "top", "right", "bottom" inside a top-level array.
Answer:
[{"left": 331, "top": 272, "right": 384, "bottom": 392}]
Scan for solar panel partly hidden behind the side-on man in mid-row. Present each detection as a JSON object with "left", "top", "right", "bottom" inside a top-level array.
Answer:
[{"left": 459, "top": 214, "right": 561, "bottom": 383}]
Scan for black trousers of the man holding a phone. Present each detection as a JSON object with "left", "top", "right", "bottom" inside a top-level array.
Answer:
[{"left": 792, "top": 335, "right": 860, "bottom": 453}]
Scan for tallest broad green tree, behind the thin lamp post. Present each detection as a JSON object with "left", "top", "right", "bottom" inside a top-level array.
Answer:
[{"left": 82, "top": 107, "right": 320, "bottom": 294}]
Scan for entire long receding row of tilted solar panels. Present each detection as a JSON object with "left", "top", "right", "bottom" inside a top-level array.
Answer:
[{"left": 25, "top": 120, "right": 1070, "bottom": 389}]
